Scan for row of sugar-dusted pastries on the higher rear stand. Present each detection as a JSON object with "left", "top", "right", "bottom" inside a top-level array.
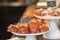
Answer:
[{"left": 36, "top": 7, "right": 60, "bottom": 16}]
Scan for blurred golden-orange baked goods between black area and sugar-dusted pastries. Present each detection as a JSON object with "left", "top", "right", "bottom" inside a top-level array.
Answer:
[{"left": 22, "top": 5, "right": 36, "bottom": 18}]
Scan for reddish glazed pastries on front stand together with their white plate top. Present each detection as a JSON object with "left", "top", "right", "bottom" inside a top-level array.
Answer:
[{"left": 7, "top": 19, "right": 50, "bottom": 36}]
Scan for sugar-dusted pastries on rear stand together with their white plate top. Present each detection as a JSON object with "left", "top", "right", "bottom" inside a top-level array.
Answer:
[{"left": 35, "top": 7, "right": 60, "bottom": 19}]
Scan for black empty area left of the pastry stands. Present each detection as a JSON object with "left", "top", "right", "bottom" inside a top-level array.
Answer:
[{"left": 0, "top": 6, "right": 26, "bottom": 40}]
